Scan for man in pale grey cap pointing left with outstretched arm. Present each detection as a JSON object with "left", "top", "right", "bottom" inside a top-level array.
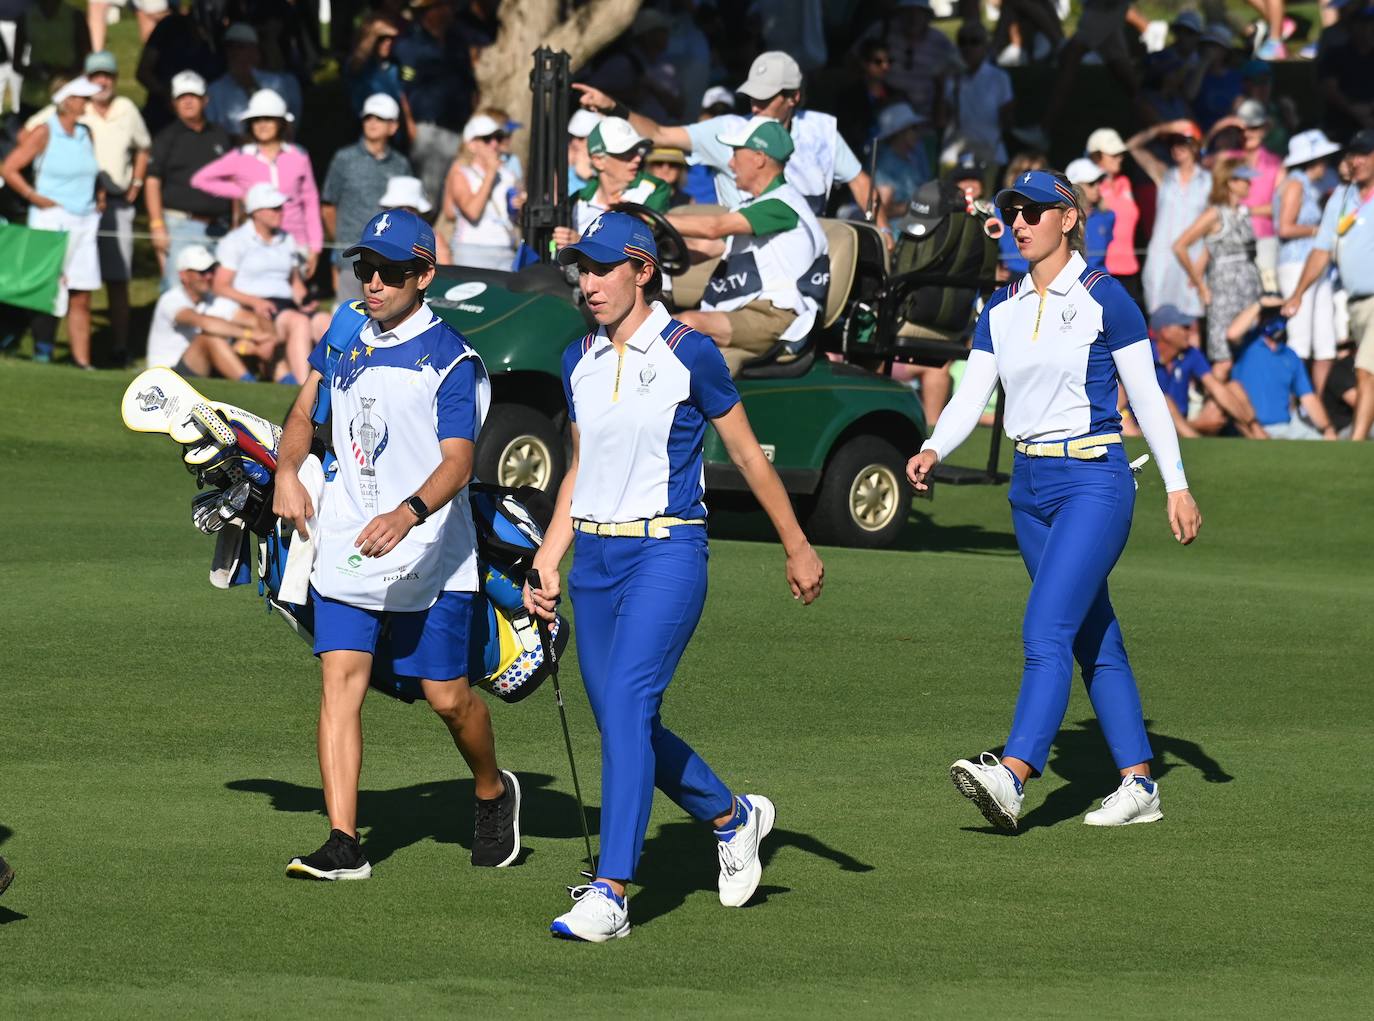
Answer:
[{"left": 573, "top": 49, "right": 886, "bottom": 229}]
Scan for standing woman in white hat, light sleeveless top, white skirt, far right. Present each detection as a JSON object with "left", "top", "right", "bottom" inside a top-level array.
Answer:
[{"left": 1274, "top": 131, "right": 1341, "bottom": 393}]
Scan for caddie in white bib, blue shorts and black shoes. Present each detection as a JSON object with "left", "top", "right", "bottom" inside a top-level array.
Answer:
[{"left": 272, "top": 209, "right": 519, "bottom": 879}]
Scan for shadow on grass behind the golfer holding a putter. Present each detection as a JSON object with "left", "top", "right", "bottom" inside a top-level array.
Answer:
[{"left": 633, "top": 820, "right": 872, "bottom": 925}]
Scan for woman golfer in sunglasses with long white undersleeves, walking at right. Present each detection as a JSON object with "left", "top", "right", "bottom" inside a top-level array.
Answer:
[{"left": 907, "top": 170, "right": 1202, "bottom": 830}]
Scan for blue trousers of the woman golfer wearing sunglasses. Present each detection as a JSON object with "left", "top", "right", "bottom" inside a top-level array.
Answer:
[{"left": 1003, "top": 445, "right": 1153, "bottom": 775}]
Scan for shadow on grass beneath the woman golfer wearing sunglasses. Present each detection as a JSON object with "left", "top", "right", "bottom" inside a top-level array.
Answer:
[{"left": 963, "top": 720, "right": 1235, "bottom": 837}]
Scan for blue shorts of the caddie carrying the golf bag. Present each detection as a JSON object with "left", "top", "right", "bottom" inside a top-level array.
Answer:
[{"left": 311, "top": 585, "right": 473, "bottom": 680}]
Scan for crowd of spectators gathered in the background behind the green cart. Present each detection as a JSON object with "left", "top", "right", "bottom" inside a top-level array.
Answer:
[{"left": 0, "top": 0, "right": 1374, "bottom": 438}]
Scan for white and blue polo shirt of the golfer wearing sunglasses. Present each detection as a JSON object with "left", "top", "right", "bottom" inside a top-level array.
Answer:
[{"left": 973, "top": 253, "right": 1149, "bottom": 441}]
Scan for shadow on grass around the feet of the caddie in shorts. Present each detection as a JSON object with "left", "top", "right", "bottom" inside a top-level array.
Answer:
[{"left": 224, "top": 772, "right": 600, "bottom": 864}]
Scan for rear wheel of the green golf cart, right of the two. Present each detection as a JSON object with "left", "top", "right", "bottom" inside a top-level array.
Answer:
[{"left": 807, "top": 436, "right": 911, "bottom": 548}]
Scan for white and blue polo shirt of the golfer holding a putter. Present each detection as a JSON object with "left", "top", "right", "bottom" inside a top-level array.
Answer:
[{"left": 563, "top": 301, "right": 739, "bottom": 522}]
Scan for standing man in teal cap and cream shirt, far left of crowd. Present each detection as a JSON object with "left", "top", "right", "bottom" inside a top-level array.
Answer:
[{"left": 25, "top": 51, "right": 153, "bottom": 366}]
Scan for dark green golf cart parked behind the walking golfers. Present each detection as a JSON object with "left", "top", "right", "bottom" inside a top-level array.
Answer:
[{"left": 429, "top": 49, "right": 1000, "bottom": 547}]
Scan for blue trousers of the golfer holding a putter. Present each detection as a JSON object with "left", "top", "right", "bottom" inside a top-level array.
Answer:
[{"left": 567, "top": 526, "right": 734, "bottom": 881}]
